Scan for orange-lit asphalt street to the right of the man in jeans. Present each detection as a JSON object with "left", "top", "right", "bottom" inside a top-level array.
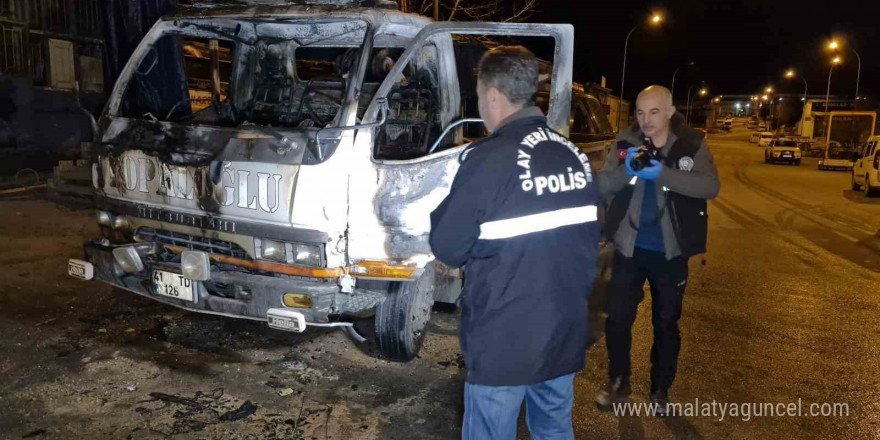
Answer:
[{"left": 575, "top": 128, "right": 880, "bottom": 439}]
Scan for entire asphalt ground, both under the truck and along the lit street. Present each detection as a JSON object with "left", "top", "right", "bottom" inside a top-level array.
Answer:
[{"left": 0, "top": 124, "right": 880, "bottom": 439}]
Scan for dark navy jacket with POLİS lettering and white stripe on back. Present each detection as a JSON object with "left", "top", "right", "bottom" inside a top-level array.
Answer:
[{"left": 431, "top": 108, "right": 599, "bottom": 386}]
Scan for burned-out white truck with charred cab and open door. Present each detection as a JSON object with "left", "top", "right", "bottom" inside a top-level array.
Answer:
[{"left": 68, "top": 0, "right": 587, "bottom": 360}]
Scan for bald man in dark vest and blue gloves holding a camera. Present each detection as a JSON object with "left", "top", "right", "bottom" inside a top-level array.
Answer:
[{"left": 596, "top": 86, "right": 720, "bottom": 416}]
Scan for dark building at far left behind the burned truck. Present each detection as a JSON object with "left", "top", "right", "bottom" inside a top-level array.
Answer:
[{"left": 0, "top": 0, "right": 106, "bottom": 173}]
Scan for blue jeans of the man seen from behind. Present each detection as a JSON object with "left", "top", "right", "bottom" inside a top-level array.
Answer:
[{"left": 461, "top": 374, "right": 574, "bottom": 440}]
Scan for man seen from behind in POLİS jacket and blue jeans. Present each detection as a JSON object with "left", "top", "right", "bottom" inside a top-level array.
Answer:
[{"left": 431, "top": 46, "right": 599, "bottom": 439}]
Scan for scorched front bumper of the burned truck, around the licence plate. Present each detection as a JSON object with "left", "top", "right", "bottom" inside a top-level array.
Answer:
[{"left": 84, "top": 241, "right": 384, "bottom": 326}]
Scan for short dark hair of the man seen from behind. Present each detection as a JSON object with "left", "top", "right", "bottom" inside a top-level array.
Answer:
[{"left": 477, "top": 46, "right": 538, "bottom": 105}]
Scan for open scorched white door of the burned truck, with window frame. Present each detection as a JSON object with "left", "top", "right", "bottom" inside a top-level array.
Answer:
[{"left": 348, "top": 23, "right": 574, "bottom": 268}]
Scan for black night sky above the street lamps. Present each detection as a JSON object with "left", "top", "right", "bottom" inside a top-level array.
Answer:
[{"left": 529, "top": 0, "right": 880, "bottom": 100}]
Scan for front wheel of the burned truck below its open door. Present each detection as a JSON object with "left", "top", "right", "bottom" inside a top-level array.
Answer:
[{"left": 375, "top": 263, "right": 436, "bottom": 361}]
